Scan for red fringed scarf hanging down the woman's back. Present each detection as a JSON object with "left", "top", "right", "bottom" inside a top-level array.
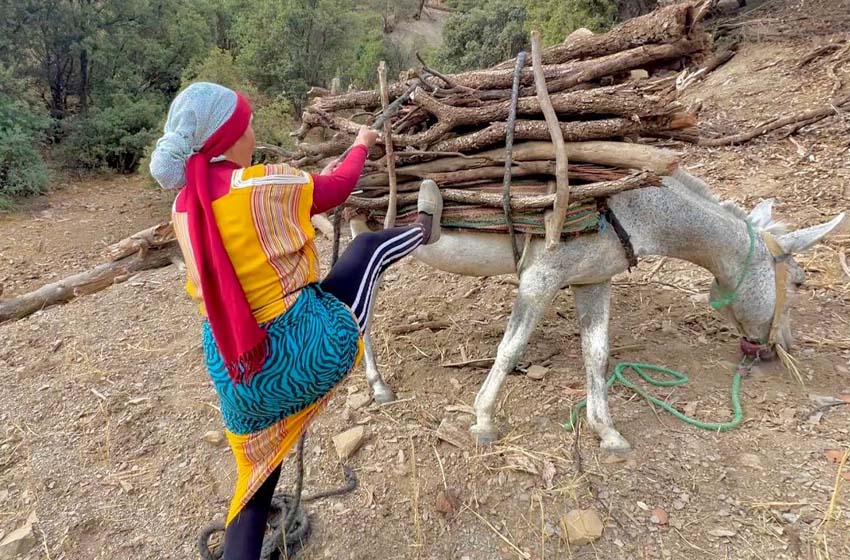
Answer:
[{"left": 185, "top": 93, "right": 268, "bottom": 383}]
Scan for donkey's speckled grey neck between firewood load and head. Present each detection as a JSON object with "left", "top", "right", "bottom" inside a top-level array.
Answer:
[{"left": 612, "top": 187, "right": 750, "bottom": 286}]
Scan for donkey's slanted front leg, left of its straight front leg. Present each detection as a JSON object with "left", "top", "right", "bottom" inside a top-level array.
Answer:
[{"left": 470, "top": 261, "right": 563, "bottom": 444}]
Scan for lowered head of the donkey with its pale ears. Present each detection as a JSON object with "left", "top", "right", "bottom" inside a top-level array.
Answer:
[{"left": 711, "top": 199, "right": 844, "bottom": 358}]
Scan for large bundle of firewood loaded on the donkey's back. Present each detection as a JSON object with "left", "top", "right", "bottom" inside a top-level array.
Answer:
[{"left": 278, "top": 3, "right": 709, "bottom": 246}]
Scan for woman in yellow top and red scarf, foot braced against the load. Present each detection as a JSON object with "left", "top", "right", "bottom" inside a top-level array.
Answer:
[{"left": 150, "top": 83, "right": 442, "bottom": 560}]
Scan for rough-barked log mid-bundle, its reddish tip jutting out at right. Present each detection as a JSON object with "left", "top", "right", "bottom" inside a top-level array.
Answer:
[{"left": 431, "top": 113, "right": 696, "bottom": 155}]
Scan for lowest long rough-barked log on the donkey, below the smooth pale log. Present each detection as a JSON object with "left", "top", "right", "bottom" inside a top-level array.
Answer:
[{"left": 345, "top": 171, "right": 661, "bottom": 212}]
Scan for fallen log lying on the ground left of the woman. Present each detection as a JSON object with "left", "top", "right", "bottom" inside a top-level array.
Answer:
[{"left": 0, "top": 249, "right": 172, "bottom": 323}]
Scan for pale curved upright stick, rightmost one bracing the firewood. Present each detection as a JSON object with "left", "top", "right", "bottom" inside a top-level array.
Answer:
[{"left": 531, "top": 30, "right": 570, "bottom": 249}]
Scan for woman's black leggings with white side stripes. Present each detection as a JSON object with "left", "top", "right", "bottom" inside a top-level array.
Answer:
[{"left": 224, "top": 223, "right": 425, "bottom": 560}]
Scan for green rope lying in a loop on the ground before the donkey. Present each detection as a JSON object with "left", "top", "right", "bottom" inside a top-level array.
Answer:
[{"left": 564, "top": 362, "right": 744, "bottom": 432}]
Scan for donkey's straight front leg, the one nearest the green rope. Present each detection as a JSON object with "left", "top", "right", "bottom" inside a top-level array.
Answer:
[{"left": 572, "top": 282, "right": 631, "bottom": 452}]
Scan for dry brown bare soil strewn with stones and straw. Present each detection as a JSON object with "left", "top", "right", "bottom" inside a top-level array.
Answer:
[{"left": 0, "top": 2, "right": 850, "bottom": 560}]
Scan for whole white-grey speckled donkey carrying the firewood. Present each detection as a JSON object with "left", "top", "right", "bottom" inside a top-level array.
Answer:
[{"left": 349, "top": 170, "right": 844, "bottom": 452}]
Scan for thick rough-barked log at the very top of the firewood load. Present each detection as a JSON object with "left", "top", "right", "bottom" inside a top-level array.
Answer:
[{"left": 494, "top": 4, "right": 693, "bottom": 69}]
